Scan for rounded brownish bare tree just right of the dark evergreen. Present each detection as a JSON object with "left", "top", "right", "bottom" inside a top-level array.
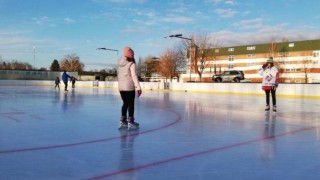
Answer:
[{"left": 60, "top": 54, "right": 84, "bottom": 72}]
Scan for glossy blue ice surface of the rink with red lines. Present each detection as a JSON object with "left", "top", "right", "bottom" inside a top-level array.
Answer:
[{"left": 0, "top": 86, "right": 320, "bottom": 180}]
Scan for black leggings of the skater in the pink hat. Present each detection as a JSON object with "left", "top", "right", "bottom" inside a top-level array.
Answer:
[{"left": 120, "top": 91, "right": 136, "bottom": 117}]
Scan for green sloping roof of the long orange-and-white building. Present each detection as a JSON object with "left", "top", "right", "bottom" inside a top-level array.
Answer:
[{"left": 205, "top": 39, "right": 320, "bottom": 56}]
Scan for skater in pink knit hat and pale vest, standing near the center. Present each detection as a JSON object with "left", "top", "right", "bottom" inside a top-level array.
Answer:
[{"left": 117, "top": 47, "right": 142, "bottom": 130}]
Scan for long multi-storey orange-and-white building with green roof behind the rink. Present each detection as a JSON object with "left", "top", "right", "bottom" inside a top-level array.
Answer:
[{"left": 182, "top": 39, "right": 320, "bottom": 83}]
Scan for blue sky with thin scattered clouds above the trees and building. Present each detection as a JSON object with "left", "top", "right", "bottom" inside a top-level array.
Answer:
[{"left": 0, "top": 0, "right": 320, "bottom": 70}]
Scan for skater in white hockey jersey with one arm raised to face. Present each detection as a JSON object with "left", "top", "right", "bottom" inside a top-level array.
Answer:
[{"left": 259, "top": 57, "right": 279, "bottom": 112}]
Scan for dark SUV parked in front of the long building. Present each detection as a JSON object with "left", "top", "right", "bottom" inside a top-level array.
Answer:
[{"left": 212, "top": 70, "right": 244, "bottom": 82}]
